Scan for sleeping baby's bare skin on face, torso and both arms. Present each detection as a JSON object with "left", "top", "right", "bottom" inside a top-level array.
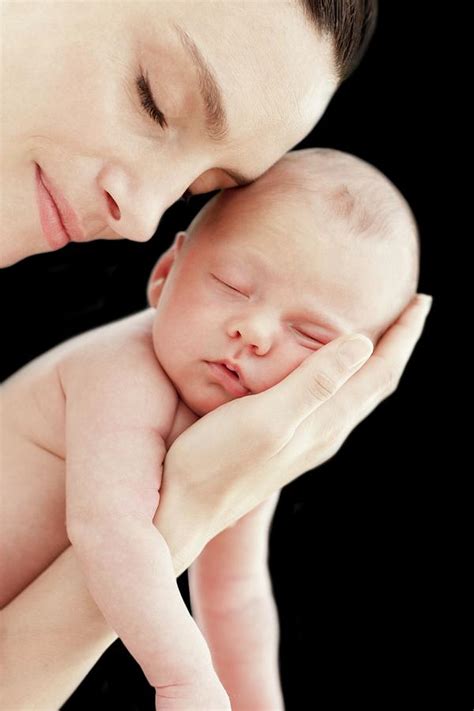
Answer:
[{"left": 2, "top": 157, "right": 422, "bottom": 708}]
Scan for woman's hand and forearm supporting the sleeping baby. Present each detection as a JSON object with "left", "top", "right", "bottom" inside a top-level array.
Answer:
[{"left": 2, "top": 295, "right": 431, "bottom": 709}]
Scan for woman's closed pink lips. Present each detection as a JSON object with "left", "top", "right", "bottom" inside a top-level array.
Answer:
[{"left": 36, "top": 164, "right": 84, "bottom": 249}]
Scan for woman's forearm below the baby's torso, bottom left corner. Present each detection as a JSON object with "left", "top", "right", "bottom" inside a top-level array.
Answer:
[{"left": 0, "top": 547, "right": 117, "bottom": 711}]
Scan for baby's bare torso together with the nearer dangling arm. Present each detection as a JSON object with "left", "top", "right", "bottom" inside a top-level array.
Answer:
[{"left": 2, "top": 312, "right": 268, "bottom": 709}]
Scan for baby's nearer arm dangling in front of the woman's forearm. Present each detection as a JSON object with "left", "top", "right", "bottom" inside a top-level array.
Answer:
[{"left": 66, "top": 362, "right": 229, "bottom": 711}]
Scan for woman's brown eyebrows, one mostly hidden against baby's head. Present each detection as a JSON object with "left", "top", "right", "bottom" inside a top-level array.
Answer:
[{"left": 174, "top": 24, "right": 255, "bottom": 185}]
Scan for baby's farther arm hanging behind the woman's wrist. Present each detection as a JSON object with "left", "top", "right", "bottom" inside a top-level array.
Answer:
[{"left": 189, "top": 492, "right": 284, "bottom": 711}]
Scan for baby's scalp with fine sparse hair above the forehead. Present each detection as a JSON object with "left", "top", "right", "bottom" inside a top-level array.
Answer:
[{"left": 189, "top": 148, "right": 420, "bottom": 301}]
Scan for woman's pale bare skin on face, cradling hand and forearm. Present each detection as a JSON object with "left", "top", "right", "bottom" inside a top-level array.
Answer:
[{"left": 1, "top": 2, "right": 430, "bottom": 708}]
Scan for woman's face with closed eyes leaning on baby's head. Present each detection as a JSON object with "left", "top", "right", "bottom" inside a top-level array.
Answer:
[{"left": 0, "top": 0, "right": 336, "bottom": 266}]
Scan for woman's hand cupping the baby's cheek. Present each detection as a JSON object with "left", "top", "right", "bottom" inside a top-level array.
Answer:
[{"left": 155, "top": 294, "right": 431, "bottom": 573}]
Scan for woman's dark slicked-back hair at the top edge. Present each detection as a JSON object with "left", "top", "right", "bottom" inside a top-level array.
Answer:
[{"left": 299, "top": 0, "right": 377, "bottom": 81}]
